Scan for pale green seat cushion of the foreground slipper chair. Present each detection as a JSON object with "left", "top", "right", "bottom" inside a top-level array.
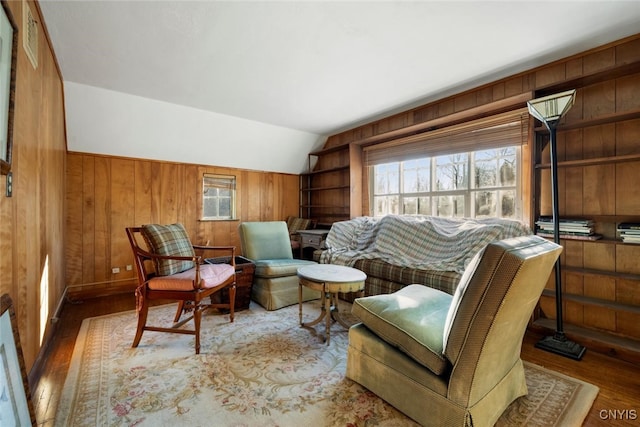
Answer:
[{"left": 352, "top": 285, "right": 452, "bottom": 375}]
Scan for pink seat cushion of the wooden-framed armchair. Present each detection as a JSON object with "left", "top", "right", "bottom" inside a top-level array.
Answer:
[{"left": 149, "top": 264, "right": 235, "bottom": 291}]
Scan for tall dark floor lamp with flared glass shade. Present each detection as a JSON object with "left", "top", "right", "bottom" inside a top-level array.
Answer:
[{"left": 527, "top": 89, "right": 585, "bottom": 360}]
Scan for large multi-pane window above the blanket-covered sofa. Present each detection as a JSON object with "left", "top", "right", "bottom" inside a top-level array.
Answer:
[{"left": 371, "top": 145, "right": 522, "bottom": 219}]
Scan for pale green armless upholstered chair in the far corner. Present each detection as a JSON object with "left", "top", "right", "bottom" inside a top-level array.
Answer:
[{"left": 239, "top": 221, "right": 320, "bottom": 310}]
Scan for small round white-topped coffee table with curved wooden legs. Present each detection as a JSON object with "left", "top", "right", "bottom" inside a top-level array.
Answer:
[{"left": 298, "top": 264, "right": 367, "bottom": 345}]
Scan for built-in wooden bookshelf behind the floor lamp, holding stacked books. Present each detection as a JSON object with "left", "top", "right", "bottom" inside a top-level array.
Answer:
[{"left": 533, "top": 56, "right": 640, "bottom": 363}]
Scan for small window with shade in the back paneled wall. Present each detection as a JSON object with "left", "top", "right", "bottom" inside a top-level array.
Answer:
[{"left": 202, "top": 173, "right": 236, "bottom": 221}]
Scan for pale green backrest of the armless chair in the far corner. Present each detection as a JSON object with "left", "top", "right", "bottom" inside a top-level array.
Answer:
[{"left": 239, "top": 221, "right": 293, "bottom": 261}]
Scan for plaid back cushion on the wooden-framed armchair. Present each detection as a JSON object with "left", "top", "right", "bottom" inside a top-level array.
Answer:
[{"left": 142, "top": 224, "right": 196, "bottom": 276}]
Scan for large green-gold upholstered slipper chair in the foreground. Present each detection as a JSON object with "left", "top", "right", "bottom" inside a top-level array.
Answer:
[{"left": 347, "top": 236, "right": 562, "bottom": 426}]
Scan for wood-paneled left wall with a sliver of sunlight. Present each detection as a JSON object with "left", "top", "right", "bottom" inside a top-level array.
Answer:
[{"left": 0, "top": 1, "right": 66, "bottom": 370}]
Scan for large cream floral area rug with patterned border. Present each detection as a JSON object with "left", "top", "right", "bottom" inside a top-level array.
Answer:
[{"left": 55, "top": 302, "right": 598, "bottom": 427}]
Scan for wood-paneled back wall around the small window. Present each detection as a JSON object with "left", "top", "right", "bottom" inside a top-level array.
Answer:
[{"left": 66, "top": 153, "right": 300, "bottom": 298}]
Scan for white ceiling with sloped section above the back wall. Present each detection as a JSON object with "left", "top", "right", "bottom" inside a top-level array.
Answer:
[{"left": 40, "top": 0, "right": 640, "bottom": 173}]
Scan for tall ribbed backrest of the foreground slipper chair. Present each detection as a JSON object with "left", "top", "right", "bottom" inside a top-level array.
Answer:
[{"left": 444, "top": 236, "right": 562, "bottom": 405}]
